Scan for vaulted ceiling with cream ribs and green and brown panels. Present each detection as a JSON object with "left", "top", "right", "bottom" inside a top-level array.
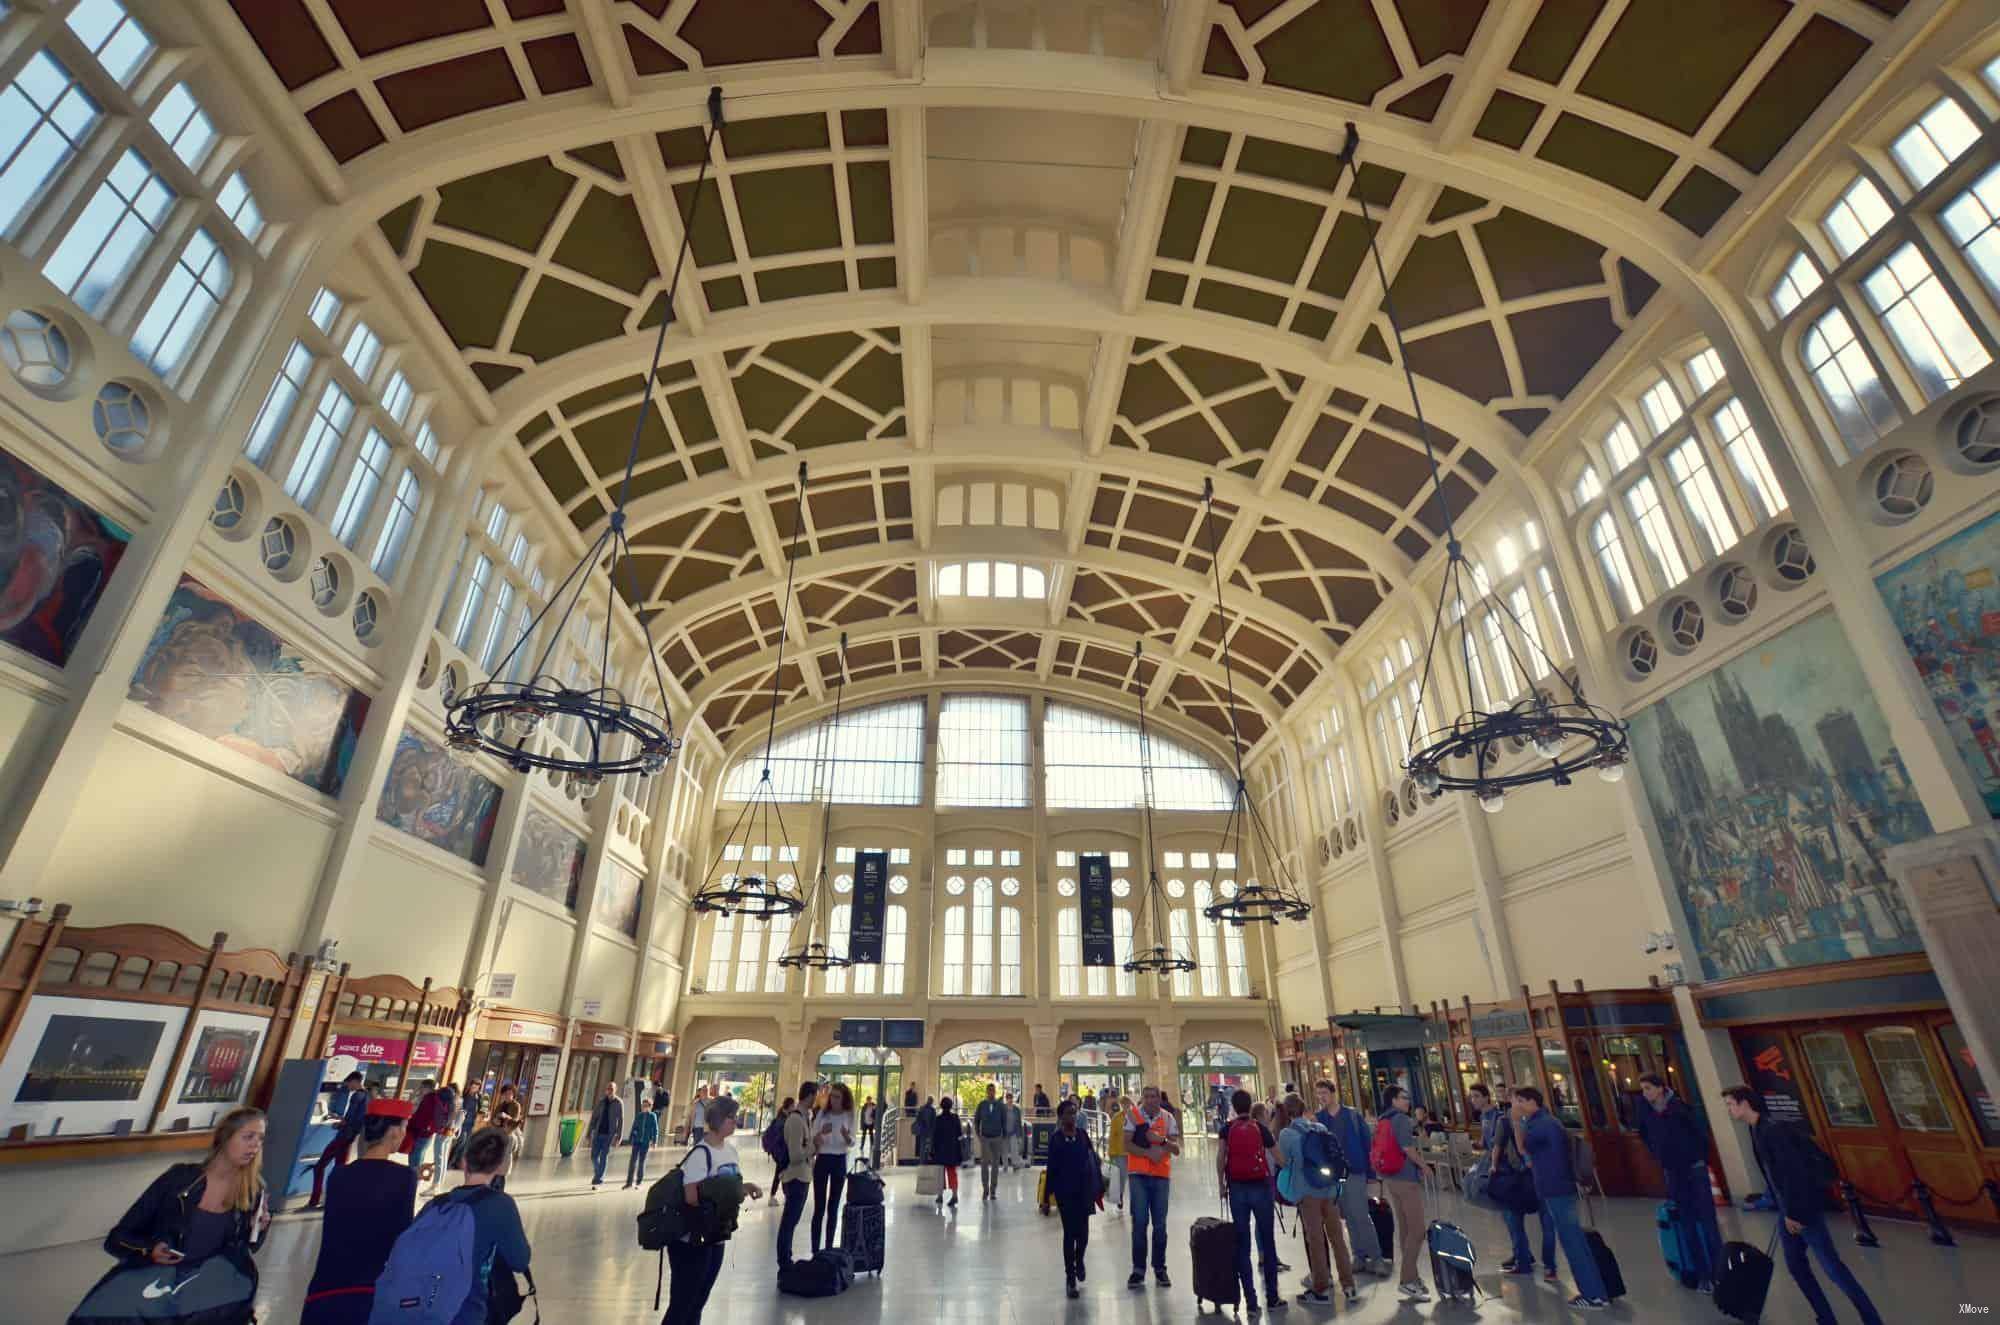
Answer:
[{"left": 219, "top": 0, "right": 1904, "bottom": 756}]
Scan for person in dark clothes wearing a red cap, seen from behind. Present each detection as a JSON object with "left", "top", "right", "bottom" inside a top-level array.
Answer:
[{"left": 300, "top": 1091, "right": 416, "bottom": 1325}]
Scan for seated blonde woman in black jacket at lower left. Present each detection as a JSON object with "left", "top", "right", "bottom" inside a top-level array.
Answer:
[{"left": 104, "top": 1109, "right": 270, "bottom": 1265}]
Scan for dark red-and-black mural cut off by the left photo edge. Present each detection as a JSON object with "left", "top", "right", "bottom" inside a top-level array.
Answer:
[{"left": 0, "top": 450, "right": 132, "bottom": 667}]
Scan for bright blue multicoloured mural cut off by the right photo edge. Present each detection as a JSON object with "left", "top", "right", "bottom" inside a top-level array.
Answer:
[{"left": 1876, "top": 514, "right": 2000, "bottom": 819}]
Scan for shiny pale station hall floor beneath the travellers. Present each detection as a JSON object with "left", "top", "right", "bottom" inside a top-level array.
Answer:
[{"left": 15, "top": 1157, "right": 2000, "bottom": 1325}]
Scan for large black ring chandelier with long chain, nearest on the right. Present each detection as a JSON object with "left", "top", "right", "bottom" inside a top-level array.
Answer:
[{"left": 1336, "top": 124, "right": 1632, "bottom": 815}]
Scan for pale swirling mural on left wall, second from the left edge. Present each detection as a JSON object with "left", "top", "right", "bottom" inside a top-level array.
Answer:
[{"left": 130, "top": 574, "right": 368, "bottom": 797}]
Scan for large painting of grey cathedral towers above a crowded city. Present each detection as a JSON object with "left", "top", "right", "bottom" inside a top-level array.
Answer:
[{"left": 1632, "top": 612, "right": 1930, "bottom": 981}]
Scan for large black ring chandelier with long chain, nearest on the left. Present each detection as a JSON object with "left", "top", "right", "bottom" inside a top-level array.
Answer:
[{"left": 444, "top": 88, "right": 722, "bottom": 801}]
